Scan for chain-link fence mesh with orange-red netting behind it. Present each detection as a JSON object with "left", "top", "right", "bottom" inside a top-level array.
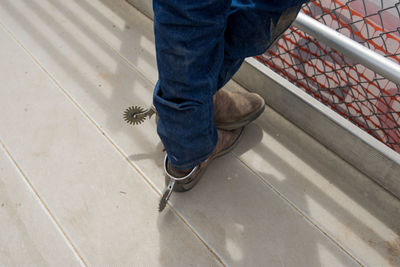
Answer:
[{"left": 257, "top": 0, "right": 400, "bottom": 153}]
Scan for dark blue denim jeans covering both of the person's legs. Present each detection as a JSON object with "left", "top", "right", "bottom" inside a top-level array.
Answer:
[{"left": 153, "top": 0, "right": 307, "bottom": 169}]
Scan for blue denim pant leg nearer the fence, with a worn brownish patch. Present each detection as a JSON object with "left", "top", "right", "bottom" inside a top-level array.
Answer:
[{"left": 218, "top": 0, "right": 309, "bottom": 89}]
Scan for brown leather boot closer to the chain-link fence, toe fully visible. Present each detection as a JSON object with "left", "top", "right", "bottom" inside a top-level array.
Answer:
[{"left": 214, "top": 88, "right": 265, "bottom": 130}]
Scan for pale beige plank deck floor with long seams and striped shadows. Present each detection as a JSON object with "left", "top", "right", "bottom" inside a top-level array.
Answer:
[{"left": 0, "top": 0, "right": 400, "bottom": 267}]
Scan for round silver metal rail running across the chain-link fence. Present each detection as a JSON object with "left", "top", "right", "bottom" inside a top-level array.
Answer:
[{"left": 293, "top": 13, "right": 400, "bottom": 84}]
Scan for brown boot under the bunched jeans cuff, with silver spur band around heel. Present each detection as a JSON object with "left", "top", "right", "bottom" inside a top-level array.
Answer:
[{"left": 165, "top": 128, "right": 243, "bottom": 192}]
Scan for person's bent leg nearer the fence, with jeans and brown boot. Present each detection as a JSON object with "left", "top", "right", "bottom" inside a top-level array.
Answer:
[{"left": 214, "top": 0, "right": 302, "bottom": 130}]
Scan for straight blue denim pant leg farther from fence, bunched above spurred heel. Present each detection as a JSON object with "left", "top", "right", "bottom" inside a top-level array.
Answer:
[{"left": 153, "top": 0, "right": 230, "bottom": 169}]
